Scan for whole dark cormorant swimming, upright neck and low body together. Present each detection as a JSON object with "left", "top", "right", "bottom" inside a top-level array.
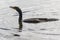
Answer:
[{"left": 10, "top": 6, "right": 58, "bottom": 29}]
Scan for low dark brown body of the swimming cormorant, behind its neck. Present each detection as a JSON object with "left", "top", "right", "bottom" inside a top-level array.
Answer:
[{"left": 23, "top": 18, "right": 58, "bottom": 23}]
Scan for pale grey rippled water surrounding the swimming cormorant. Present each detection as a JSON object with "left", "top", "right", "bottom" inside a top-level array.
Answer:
[{"left": 0, "top": 0, "right": 60, "bottom": 40}]
